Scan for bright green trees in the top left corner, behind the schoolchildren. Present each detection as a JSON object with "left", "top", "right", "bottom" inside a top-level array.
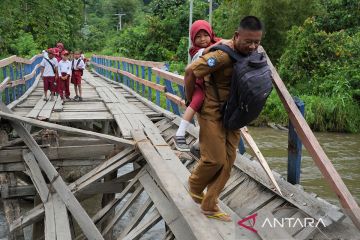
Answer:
[{"left": 0, "top": 0, "right": 83, "bottom": 57}]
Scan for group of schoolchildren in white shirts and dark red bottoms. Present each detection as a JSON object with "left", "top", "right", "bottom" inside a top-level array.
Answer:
[{"left": 40, "top": 43, "right": 86, "bottom": 103}]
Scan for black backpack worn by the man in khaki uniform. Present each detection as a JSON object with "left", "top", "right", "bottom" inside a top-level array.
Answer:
[{"left": 211, "top": 45, "right": 272, "bottom": 130}]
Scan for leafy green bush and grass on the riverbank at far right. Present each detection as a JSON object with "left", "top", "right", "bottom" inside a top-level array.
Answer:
[{"left": 279, "top": 0, "right": 360, "bottom": 132}]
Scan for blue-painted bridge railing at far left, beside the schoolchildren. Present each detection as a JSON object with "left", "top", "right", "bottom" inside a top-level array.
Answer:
[{"left": 0, "top": 54, "right": 43, "bottom": 104}]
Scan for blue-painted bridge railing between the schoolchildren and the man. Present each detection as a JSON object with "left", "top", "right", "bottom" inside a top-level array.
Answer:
[{"left": 91, "top": 55, "right": 185, "bottom": 116}]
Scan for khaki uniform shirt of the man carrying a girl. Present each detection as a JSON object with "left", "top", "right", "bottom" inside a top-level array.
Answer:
[{"left": 190, "top": 50, "right": 233, "bottom": 120}]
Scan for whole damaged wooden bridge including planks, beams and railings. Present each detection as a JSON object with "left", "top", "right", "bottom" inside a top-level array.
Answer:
[{"left": 0, "top": 51, "right": 360, "bottom": 240}]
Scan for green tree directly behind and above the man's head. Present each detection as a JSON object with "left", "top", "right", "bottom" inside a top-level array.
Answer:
[{"left": 213, "top": 0, "right": 321, "bottom": 62}]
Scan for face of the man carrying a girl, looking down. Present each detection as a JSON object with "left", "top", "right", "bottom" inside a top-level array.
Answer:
[{"left": 234, "top": 29, "right": 262, "bottom": 55}]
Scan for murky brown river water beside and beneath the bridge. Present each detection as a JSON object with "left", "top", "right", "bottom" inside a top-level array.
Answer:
[{"left": 0, "top": 127, "right": 360, "bottom": 240}]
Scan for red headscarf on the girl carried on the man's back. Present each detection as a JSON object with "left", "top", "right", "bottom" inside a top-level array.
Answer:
[{"left": 189, "top": 20, "right": 221, "bottom": 58}]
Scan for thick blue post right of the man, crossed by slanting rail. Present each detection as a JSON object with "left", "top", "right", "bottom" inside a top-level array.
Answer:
[{"left": 287, "top": 97, "right": 305, "bottom": 184}]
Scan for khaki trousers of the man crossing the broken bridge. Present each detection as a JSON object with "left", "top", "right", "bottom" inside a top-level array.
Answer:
[{"left": 189, "top": 115, "right": 240, "bottom": 211}]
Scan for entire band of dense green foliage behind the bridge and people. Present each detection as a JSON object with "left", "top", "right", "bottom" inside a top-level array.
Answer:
[{"left": 0, "top": 0, "right": 360, "bottom": 132}]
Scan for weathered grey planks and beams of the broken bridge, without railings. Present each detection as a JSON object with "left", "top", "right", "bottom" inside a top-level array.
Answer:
[{"left": 0, "top": 68, "right": 359, "bottom": 240}]
